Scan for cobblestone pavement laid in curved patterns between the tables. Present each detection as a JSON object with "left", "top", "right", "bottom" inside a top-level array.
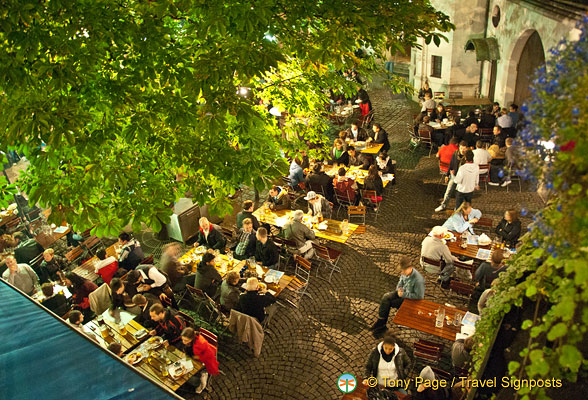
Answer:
[{"left": 180, "top": 90, "right": 540, "bottom": 400}]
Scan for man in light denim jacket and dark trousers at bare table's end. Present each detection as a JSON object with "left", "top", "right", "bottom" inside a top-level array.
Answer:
[{"left": 370, "top": 256, "right": 425, "bottom": 331}]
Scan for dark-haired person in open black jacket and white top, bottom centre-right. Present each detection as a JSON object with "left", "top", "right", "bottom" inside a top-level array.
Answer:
[{"left": 363, "top": 330, "right": 412, "bottom": 398}]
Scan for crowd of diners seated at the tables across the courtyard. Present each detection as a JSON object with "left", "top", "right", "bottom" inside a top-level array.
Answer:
[{"left": 0, "top": 79, "right": 532, "bottom": 399}]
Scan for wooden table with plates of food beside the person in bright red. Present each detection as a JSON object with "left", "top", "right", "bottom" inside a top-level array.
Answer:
[{"left": 130, "top": 342, "right": 204, "bottom": 392}]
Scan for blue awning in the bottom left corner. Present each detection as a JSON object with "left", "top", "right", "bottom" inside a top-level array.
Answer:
[{"left": 0, "top": 280, "right": 180, "bottom": 400}]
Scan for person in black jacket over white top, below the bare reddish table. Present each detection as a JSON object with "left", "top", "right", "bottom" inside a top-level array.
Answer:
[{"left": 363, "top": 330, "right": 411, "bottom": 385}]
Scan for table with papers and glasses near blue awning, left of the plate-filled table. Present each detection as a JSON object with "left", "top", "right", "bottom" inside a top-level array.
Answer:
[{"left": 85, "top": 310, "right": 151, "bottom": 353}]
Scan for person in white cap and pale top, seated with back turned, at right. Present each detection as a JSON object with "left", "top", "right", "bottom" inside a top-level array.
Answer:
[{"left": 421, "top": 226, "right": 455, "bottom": 289}]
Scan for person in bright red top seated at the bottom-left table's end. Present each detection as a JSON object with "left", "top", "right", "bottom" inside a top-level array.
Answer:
[{"left": 182, "top": 328, "right": 219, "bottom": 394}]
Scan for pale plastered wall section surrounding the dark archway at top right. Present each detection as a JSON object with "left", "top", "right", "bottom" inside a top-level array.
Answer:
[{"left": 483, "top": 0, "right": 580, "bottom": 105}]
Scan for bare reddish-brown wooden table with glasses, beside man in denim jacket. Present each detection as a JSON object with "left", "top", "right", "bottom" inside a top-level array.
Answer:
[{"left": 393, "top": 299, "right": 466, "bottom": 342}]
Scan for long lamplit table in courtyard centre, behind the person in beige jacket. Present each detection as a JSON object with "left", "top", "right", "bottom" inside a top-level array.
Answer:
[{"left": 253, "top": 206, "right": 358, "bottom": 243}]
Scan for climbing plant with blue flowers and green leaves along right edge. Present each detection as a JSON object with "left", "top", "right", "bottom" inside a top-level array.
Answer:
[{"left": 472, "top": 17, "right": 588, "bottom": 399}]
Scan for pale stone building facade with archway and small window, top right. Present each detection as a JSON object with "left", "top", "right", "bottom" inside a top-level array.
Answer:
[{"left": 409, "top": 0, "right": 588, "bottom": 105}]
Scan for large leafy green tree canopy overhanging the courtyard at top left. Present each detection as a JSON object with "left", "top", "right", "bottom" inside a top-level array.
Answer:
[{"left": 0, "top": 0, "right": 453, "bottom": 235}]
